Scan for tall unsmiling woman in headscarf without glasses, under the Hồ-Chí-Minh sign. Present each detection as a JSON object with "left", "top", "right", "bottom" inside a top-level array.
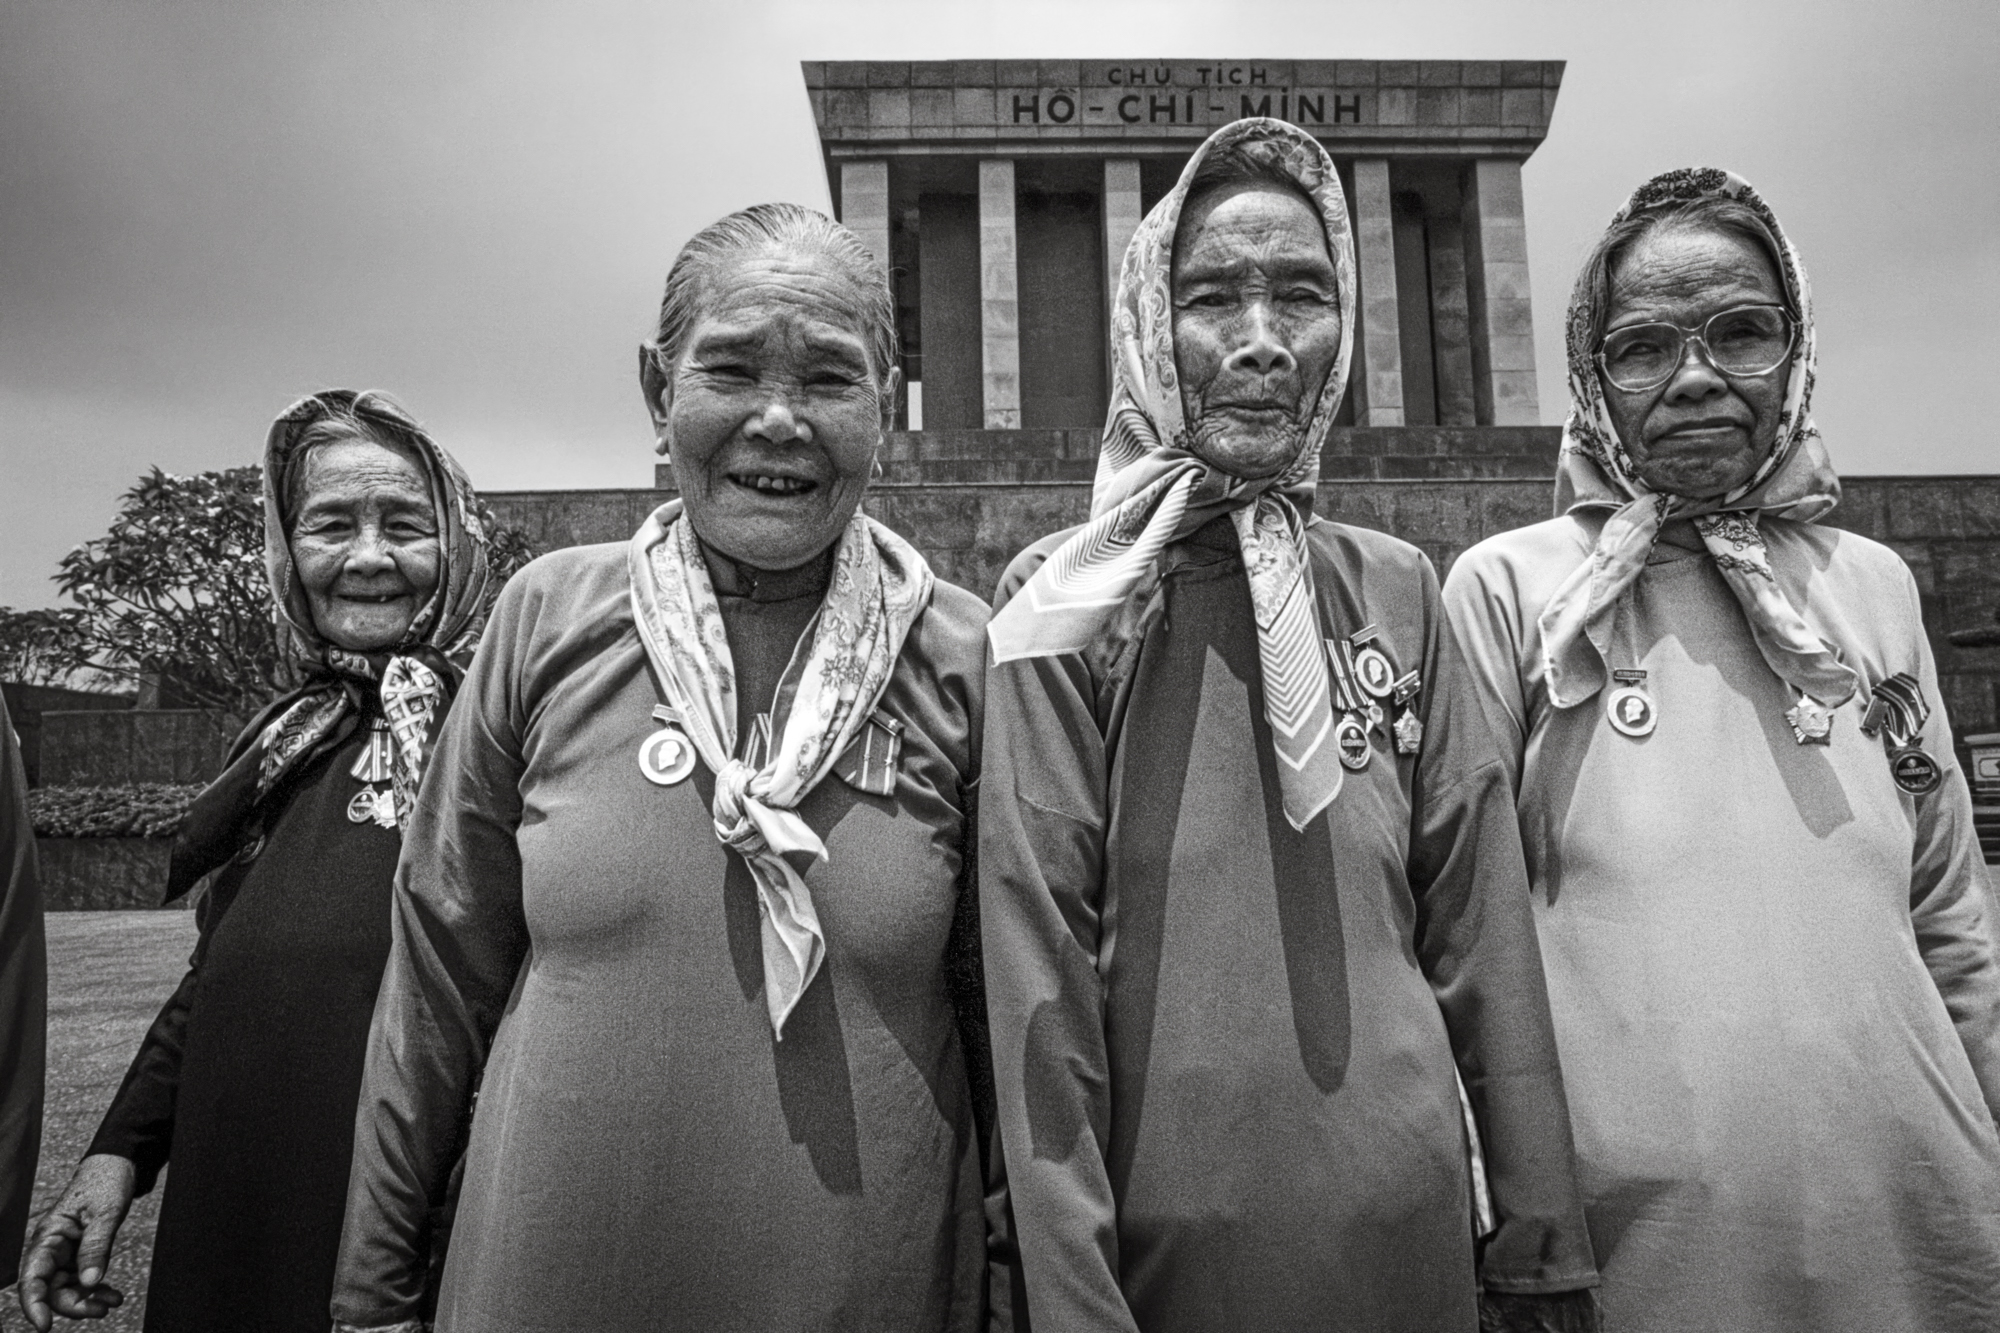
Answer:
[{"left": 980, "top": 118, "right": 1596, "bottom": 1333}]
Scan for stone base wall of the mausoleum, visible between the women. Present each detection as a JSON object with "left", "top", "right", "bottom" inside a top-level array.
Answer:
[{"left": 488, "top": 426, "right": 2000, "bottom": 735}]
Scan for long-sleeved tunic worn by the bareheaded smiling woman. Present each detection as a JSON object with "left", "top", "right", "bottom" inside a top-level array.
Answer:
[{"left": 334, "top": 544, "right": 986, "bottom": 1333}]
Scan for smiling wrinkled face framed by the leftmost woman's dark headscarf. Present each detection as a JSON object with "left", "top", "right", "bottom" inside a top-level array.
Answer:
[{"left": 292, "top": 440, "right": 440, "bottom": 652}]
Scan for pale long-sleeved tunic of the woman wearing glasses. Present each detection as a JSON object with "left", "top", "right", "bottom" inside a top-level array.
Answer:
[{"left": 1446, "top": 516, "right": 2000, "bottom": 1333}]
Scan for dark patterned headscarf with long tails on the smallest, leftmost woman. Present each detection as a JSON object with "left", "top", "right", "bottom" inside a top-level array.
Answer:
[{"left": 166, "top": 388, "right": 490, "bottom": 901}]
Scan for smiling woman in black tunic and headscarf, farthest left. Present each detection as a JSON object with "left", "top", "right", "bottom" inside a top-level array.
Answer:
[{"left": 20, "top": 390, "right": 488, "bottom": 1333}]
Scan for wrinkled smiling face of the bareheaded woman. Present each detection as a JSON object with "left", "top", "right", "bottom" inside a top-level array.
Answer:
[{"left": 642, "top": 252, "right": 898, "bottom": 570}]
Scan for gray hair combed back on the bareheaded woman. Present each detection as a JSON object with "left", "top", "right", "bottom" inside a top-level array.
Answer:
[{"left": 654, "top": 204, "right": 896, "bottom": 382}]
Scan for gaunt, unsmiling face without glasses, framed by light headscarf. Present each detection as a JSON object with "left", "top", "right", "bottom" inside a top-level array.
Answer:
[{"left": 1172, "top": 182, "right": 1340, "bottom": 478}]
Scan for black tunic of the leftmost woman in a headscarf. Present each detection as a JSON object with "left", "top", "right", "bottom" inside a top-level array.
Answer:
[{"left": 90, "top": 725, "right": 400, "bottom": 1333}]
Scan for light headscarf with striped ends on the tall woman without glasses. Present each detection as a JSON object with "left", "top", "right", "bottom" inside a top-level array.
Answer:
[{"left": 988, "top": 118, "right": 1354, "bottom": 829}]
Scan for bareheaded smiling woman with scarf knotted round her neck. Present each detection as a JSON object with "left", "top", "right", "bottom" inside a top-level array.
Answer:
[{"left": 334, "top": 204, "right": 986, "bottom": 1333}]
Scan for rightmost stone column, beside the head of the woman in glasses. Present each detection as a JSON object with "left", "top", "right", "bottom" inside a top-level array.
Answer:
[{"left": 1464, "top": 158, "right": 1542, "bottom": 426}]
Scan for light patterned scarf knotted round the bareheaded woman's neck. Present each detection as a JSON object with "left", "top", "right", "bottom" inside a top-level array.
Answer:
[{"left": 626, "top": 500, "right": 932, "bottom": 1041}]
